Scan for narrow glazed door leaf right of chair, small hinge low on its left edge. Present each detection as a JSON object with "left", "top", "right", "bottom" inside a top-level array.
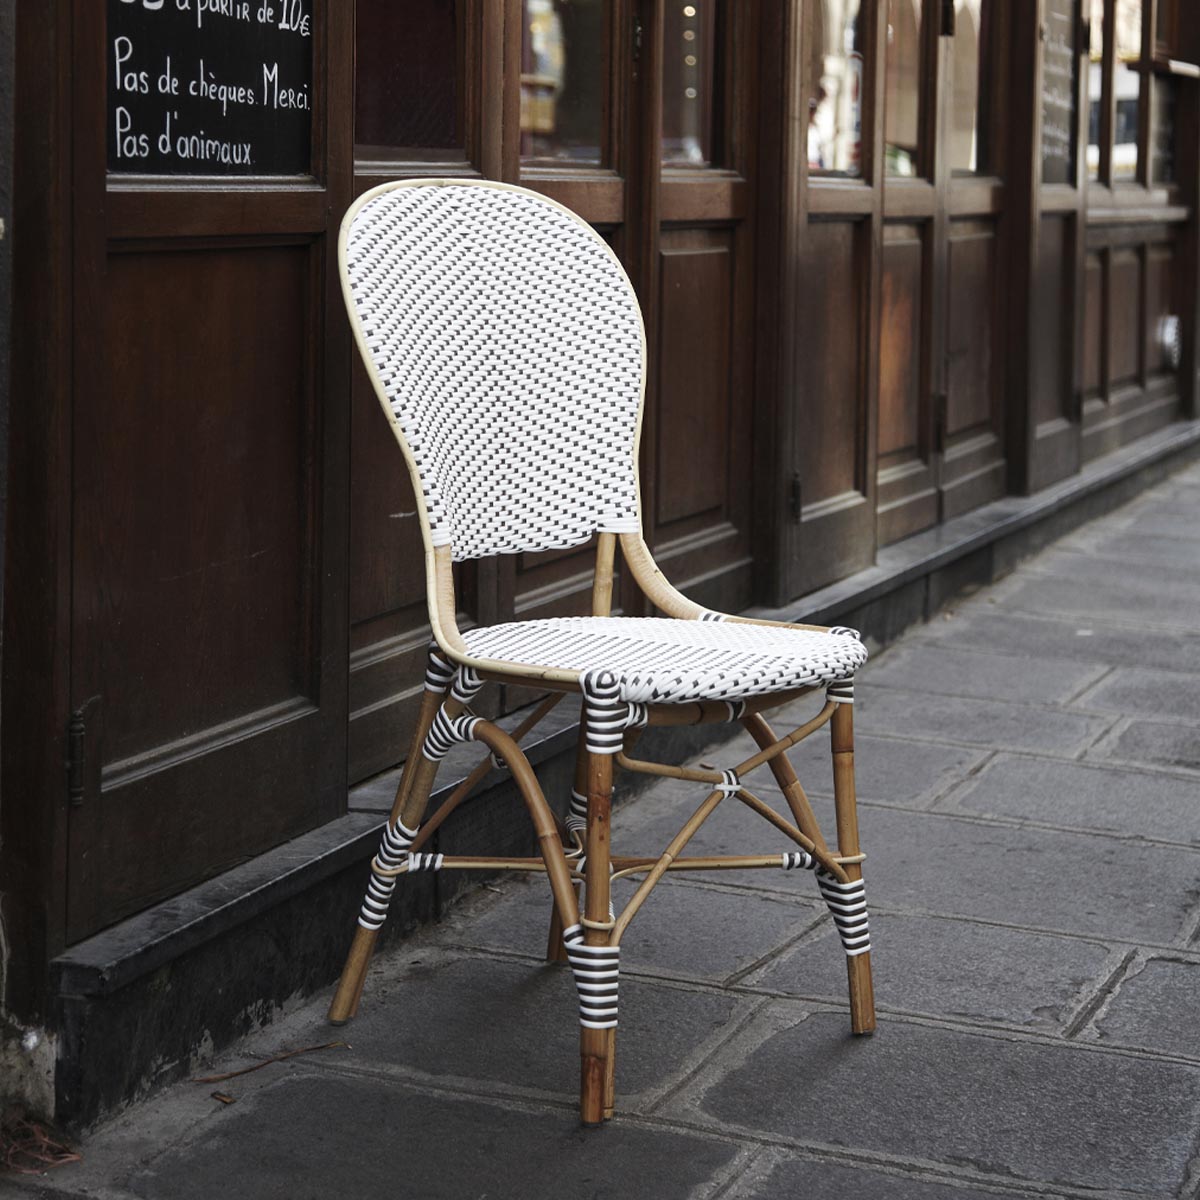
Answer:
[{"left": 779, "top": 0, "right": 886, "bottom": 596}]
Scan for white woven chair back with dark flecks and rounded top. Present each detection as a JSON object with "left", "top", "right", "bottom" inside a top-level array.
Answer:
[{"left": 341, "top": 180, "right": 646, "bottom": 559}]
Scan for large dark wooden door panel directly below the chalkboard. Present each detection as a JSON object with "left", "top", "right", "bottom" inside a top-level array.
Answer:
[{"left": 74, "top": 246, "right": 318, "bottom": 766}]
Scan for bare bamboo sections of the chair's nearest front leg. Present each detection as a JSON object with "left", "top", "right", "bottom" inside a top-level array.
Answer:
[{"left": 580, "top": 754, "right": 617, "bottom": 1126}]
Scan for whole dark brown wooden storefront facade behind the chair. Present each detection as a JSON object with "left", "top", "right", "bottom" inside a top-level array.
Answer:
[{"left": 0, "top": 0, "right": 1200, "bottom": 1099}]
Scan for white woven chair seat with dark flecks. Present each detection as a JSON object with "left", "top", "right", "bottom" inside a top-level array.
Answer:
[{"left": 462, "top": 617, "right": 866, "bottom": 704}]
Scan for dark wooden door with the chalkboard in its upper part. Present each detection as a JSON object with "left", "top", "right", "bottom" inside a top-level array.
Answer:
[{"left": 66, "top": 0, "right": 352, "bottom": 941}]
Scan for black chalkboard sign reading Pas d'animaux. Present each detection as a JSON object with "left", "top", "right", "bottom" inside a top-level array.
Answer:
[{"left": 106, "top": 0, "right": 313, "bottom": 175}]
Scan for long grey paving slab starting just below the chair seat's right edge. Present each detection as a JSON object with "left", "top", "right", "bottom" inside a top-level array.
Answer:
[{"left": 854, "top": 684, "right": 1111, "bottom": 755}]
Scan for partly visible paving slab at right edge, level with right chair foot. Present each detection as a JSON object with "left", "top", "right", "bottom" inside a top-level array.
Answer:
[{"left": 1094, "top": 958, "right": 1200, "bottom": 1058}]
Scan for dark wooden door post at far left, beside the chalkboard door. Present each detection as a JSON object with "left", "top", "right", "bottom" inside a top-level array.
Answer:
[{"left": 0, "top": 0, "right": 73, "bottom": 1021}]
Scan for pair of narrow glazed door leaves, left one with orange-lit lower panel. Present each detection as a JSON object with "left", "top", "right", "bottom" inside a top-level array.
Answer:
[{"left": 878, "top": 0, "right": 1009, "bottom": 544}]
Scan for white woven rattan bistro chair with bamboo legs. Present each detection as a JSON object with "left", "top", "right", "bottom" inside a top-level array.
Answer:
[{"left": 329, "top": 180, "right": 875, "bottom": 1124}]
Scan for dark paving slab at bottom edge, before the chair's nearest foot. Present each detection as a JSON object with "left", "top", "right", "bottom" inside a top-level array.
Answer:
[{"left": 130, "top": 1075, "right": 737, "bottom": 1200}]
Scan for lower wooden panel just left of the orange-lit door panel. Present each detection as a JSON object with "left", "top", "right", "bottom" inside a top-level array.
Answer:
[{"left": 793, "top": 221, "right": 875, "bottom": 590}]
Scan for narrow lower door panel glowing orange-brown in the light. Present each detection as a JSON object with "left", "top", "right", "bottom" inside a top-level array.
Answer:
[{"left": 877, "top": 222, "right": 937, "bottom": 545}]
